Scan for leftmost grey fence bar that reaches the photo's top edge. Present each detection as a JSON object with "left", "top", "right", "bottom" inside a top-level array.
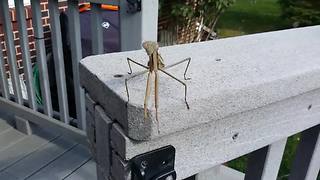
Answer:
[{"left": 0, "top": 0, "right": 23, "bottom": 104}]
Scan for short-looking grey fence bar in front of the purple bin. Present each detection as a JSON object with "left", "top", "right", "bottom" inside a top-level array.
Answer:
[{"left": 90, "top": 3, "right": 103, "bottom": 54}]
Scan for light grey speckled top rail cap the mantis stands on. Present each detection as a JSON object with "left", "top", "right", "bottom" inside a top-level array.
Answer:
[{"left": 80, "top": 26, "right": 320, "bottom": 140}]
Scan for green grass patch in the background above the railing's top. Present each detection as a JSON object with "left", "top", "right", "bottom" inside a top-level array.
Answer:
[{"left": 217, "top": 0, "right": 290, "bottom": 37}]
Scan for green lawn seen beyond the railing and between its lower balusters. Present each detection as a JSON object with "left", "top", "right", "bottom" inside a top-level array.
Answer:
[{"left": 216, "top": 0, "right": 320, "bottom": 180}]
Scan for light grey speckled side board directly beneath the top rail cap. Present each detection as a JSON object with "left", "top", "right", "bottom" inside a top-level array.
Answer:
[{"left": 110, "top": 89, "right": 320, "bottom": 180}]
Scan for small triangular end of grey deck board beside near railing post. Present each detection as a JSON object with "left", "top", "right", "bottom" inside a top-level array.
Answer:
[{"left": 65, "top": 160, "right": 97, "bottom": 180}]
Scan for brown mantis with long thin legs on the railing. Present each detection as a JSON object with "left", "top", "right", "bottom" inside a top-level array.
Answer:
[{"left": 125, "top": 41, "right": 191, "bottom": 126}]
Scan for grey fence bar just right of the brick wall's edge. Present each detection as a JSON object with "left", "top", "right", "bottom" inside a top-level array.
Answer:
[{"left": 49, "top": 0, "right": 69, "bottom": 123}]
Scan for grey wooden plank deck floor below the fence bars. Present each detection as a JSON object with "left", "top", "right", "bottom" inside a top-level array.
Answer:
[{"left": 0, "top": 119, "right": 97, "bottom": 180}]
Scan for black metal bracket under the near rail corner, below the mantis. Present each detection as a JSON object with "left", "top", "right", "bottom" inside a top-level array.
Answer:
[{"left": 130, "top": 146, "right": 177, "bottom": 180}]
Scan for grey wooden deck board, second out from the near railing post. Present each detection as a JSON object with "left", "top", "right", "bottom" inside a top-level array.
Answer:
[{"left": 26, "top": 145, "right": 91, "bottom": 180}]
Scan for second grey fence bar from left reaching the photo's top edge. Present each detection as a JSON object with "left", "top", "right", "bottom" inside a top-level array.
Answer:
[{"left": 15, "top": 1, "right": 37, "bottom": 110}]
